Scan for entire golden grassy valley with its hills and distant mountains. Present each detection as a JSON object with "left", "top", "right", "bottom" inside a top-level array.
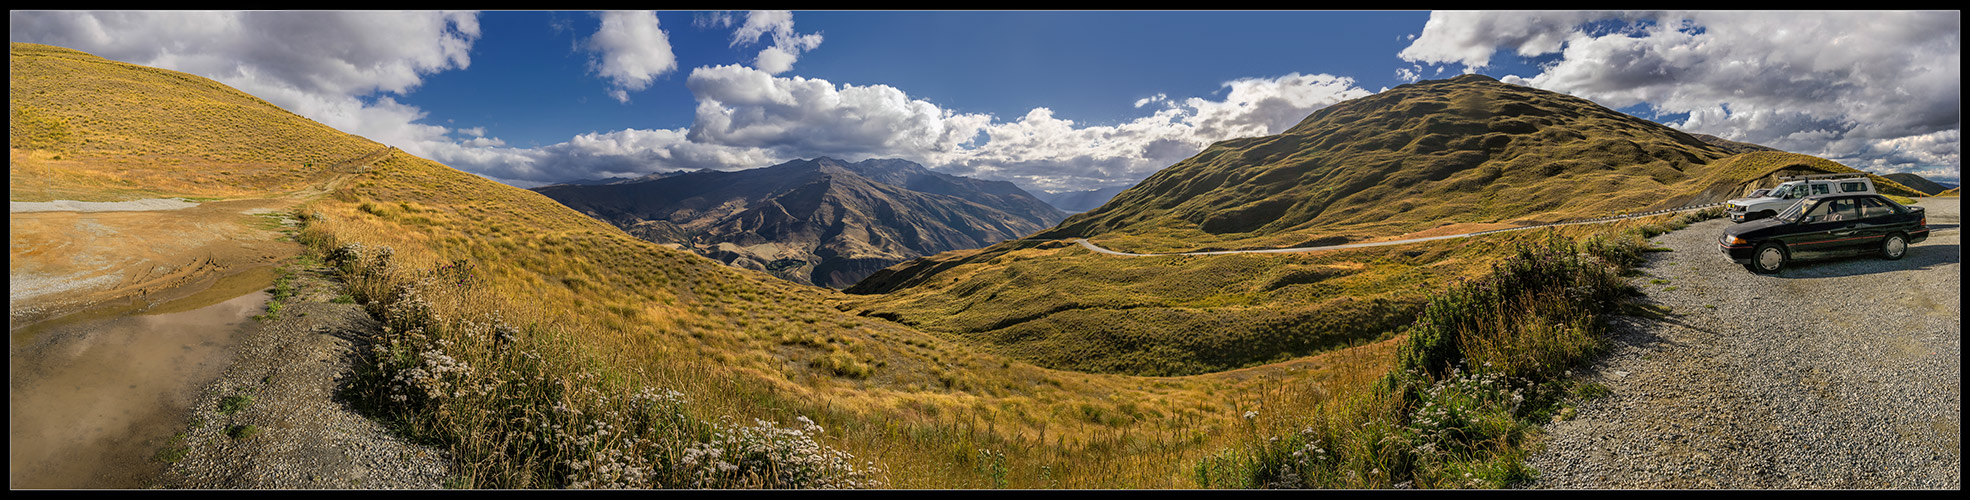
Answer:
[{"left": 10, "top": 43, "right": 1954, "bottom": 488}]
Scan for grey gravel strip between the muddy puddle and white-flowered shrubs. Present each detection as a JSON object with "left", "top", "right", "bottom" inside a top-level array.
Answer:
[{"left": 156, "top": 268, "right": 453, "bottom": 490}]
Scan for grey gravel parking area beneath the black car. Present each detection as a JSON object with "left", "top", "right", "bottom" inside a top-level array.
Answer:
[{"left": 1527, "top": 199, "right": 1962, "bottom": 488}]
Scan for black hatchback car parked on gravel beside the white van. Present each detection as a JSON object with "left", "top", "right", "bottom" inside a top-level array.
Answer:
[{"left": 1718, "top": 195, "right": 1929, "bottom": 274}]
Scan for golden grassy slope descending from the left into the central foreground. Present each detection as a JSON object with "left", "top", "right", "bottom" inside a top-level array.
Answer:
[{"left": 291, "top": 156, "right": 1389, "bottom": 488}]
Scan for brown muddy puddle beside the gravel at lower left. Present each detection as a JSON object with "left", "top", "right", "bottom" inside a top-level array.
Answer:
[{"left": 8, "top": 272, "right": 272, "bottom": 488}]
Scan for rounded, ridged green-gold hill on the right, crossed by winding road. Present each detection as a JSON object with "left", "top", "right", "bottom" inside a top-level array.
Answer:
[{"left": 847, "top": 75, "right": 1913, "bottom": 374}]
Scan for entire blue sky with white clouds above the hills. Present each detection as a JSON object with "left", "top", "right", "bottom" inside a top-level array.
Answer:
[{"left": 10, "top": 12, "right": 1962, "bottom": 191}]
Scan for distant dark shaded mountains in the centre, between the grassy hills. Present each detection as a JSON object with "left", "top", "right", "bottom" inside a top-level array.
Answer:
[{"left": 534, "top": 157, "right": 1066, "bottom": 287}]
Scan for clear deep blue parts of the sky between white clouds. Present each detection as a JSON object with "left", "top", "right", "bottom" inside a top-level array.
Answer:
[{"left": 398, "top": 12, "right": 1465, "bottom": 146}]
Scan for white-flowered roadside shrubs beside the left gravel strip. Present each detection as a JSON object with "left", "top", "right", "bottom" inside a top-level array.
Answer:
[{"left": 327, "top": 237, "right": 887, "bottom": 488}]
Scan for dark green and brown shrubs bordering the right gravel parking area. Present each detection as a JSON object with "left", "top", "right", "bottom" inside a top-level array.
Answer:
[{"left": 1221, "top": 232, "right": 1647, "bottom": 488}]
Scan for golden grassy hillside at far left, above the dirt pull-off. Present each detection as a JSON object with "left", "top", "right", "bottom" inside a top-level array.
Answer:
[{"left": 8, "top": 43, "right": 382, "bottom": 201}]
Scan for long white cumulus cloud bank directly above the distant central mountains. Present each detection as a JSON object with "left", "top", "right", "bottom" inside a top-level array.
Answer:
[{"left": 433, "top": 65, "right": 1367, "bottom": 189}]
